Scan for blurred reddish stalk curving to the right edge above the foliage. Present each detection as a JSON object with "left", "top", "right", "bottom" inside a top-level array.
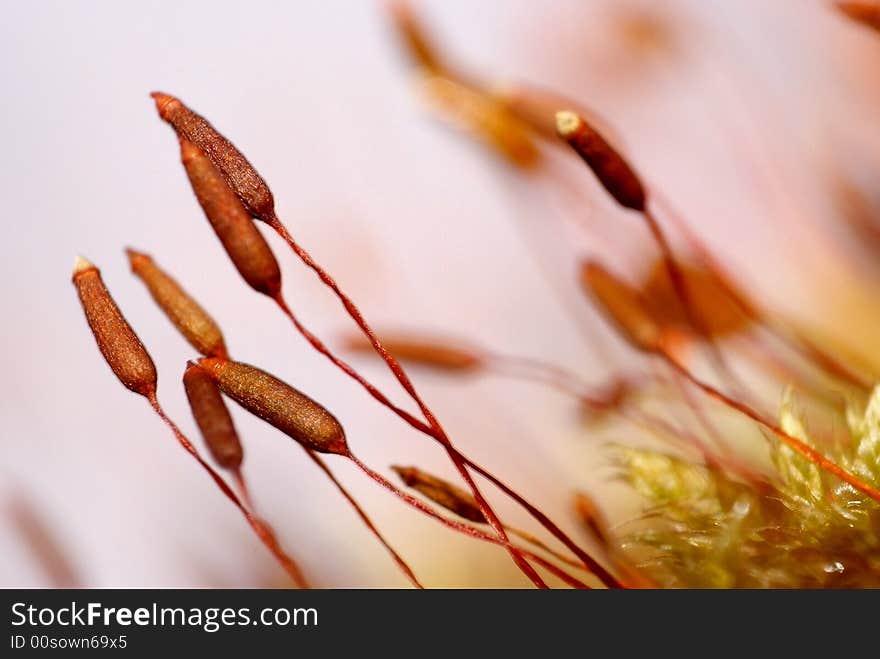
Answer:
[{"left": 648, "top": 197, "right": 871, "bottom": 390}]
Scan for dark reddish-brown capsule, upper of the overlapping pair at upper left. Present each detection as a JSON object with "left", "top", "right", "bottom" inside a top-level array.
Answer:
[{"left": 151, "top": 92, "right": 275, "bottom": 222}]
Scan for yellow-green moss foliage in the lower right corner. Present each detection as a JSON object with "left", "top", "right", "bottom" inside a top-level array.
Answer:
[{"left": 616, "top": 387, "right": 880, "bottom": 588}]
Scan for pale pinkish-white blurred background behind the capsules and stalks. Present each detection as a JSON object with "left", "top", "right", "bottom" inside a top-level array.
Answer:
[{"left": 0, "top": 0, "right": 880, "bottom": 587}]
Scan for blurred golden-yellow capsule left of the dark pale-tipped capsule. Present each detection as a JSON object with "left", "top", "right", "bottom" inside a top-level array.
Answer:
[{"left": 422, "top": 75, "right": 541, "bottom": 169}]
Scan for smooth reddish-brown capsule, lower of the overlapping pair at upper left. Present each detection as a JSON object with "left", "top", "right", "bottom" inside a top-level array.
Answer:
[{"left": 180, "top": 139, "right": 281, "bottom": 297}]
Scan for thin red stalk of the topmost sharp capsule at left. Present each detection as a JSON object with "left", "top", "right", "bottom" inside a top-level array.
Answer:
[{"left": 269, "top": 217, "right": 546, "bottom": 587}]
